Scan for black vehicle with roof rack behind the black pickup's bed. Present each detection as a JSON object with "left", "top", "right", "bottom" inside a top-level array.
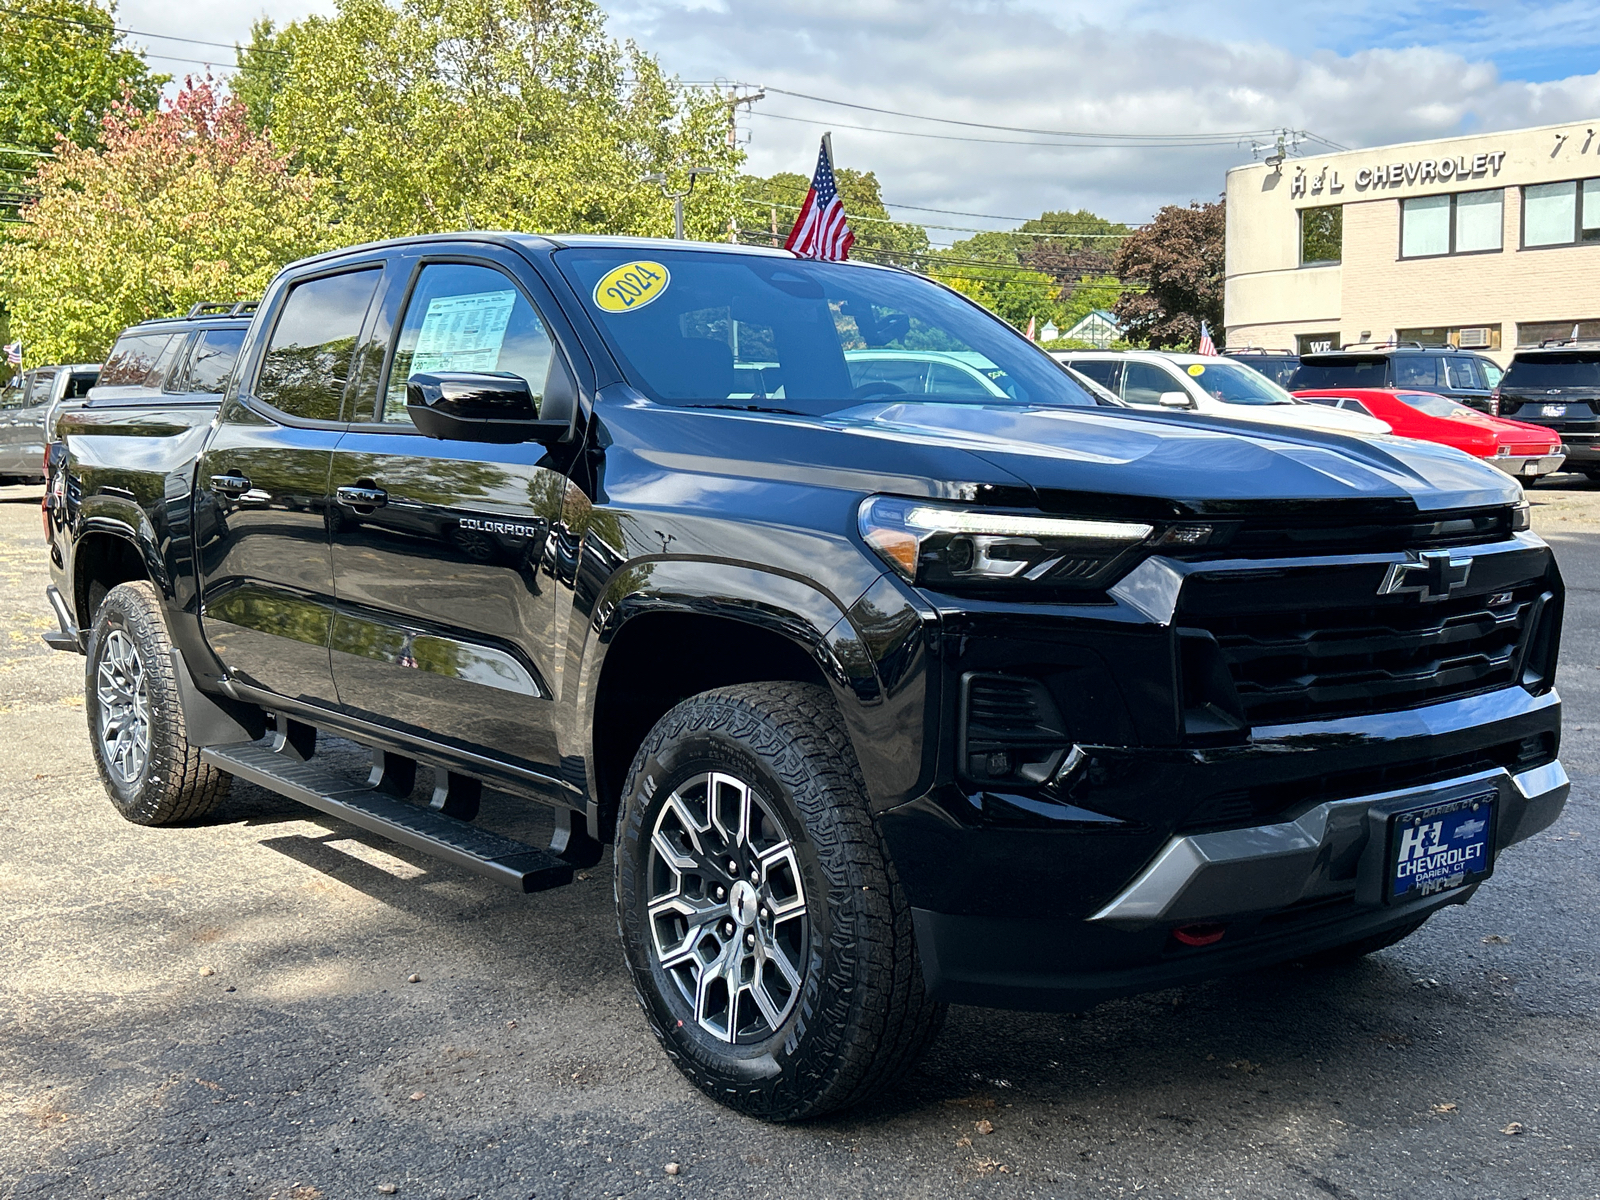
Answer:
[{"left": 90, "top": 301, "right": 256, "bottom": 405}]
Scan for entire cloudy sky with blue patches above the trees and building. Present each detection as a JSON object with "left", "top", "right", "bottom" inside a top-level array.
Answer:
[{"left": 118, "top": 0, "right": 1600, "bottom": 242}]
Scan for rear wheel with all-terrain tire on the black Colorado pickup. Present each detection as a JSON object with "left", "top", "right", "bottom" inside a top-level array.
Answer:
[{"left": 83, "top": 581, "right": 232, "bottom": 826}]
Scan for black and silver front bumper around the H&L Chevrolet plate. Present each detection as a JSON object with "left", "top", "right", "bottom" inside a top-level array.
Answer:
[{"left": 882, "top": 686, "right": 1570, "bottom": 1011}]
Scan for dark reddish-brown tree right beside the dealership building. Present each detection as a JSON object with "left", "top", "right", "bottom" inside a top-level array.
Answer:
[{"left": 1115, "top": 202, "right": 1224, "bottom": 350}]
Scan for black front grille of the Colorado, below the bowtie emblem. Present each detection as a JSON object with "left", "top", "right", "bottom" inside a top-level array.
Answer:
[{"left": 1184, "top": 584, "right": 1541, "bottom": 725}]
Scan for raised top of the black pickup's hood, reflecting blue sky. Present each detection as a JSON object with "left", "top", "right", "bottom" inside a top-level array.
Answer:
[{"left": 827, "top": 403, "right": 1522, "bottom": 512}]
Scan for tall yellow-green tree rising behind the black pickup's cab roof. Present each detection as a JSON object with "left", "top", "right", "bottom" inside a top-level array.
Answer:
[{"left": 234, "top": 0, "right": 741, "bottom": 242}]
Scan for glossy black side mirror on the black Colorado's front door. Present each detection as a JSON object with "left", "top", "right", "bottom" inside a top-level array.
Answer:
[{"left": 405, "top": 360, "right": 578, "bottom": 445}]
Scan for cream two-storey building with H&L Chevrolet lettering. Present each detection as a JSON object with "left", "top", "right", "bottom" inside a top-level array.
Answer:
[{"left": 1226, "top": 118, "right": 1600, "bottom": 363}]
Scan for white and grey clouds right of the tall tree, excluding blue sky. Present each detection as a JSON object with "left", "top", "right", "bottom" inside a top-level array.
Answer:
[{"left": 613, "top": 0, "right": 1600, "bottom": 224}]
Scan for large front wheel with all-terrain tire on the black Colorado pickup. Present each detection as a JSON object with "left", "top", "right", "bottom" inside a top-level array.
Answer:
[{"left": 614, "top": 683, "right": 946, "bottom": 1122}]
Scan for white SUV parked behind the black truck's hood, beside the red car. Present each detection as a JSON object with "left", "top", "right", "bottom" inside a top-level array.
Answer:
[{"left": 1051, "top": 350, "right": 1390, "bottom": 437}]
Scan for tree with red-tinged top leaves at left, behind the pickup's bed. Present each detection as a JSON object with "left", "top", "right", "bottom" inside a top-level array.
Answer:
[{"left": 0, "top": 82, "right": 346, "bottom": 362}]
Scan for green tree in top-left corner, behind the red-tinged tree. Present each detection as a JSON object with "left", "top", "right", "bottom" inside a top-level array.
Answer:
[{"left": 0, "top": 0, "right": 166, "bottom": 155}]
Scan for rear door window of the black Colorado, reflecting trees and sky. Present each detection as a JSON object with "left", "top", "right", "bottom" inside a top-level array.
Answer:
[{"left": 256, "top": 267, "right": 382, "bottom": 421}]
